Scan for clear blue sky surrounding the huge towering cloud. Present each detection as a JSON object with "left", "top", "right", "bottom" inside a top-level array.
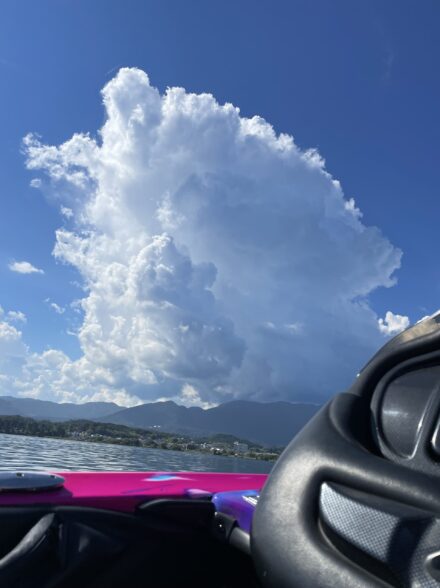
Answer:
[{"left": 0, "top": 0, "right": 440, "bottom": 404}]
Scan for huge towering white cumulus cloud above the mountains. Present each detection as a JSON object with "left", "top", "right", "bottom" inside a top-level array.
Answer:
[{"left": 11, "top": 69, "right": 401, "bottom": 404}]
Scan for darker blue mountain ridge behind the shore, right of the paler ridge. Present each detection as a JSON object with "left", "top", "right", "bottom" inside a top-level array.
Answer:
[{"left": 99, "top": 400, "right": 319, "bottom": 446}]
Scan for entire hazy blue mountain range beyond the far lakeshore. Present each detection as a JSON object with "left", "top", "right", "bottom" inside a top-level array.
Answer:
[{"left": 0, "top": 396, "right": 319, "bottom": 446}]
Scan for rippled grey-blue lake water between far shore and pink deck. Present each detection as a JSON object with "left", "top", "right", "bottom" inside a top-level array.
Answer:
[{"left": 0, "top": 434, "right": 274, "bottom": 474}]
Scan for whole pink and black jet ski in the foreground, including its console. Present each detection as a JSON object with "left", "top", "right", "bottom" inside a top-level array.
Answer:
[{"left": 0, "top": 314, "right": 440, "bottom": 588}]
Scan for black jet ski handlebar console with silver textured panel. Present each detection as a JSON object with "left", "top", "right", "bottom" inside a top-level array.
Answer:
[{"left": 251, "top": 315, "right": 440, "bottom": 588}]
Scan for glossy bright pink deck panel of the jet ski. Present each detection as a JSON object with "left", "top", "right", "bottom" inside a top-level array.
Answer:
[{"left": 0, "top": 472, "right": 267, "bottom": 512}]
